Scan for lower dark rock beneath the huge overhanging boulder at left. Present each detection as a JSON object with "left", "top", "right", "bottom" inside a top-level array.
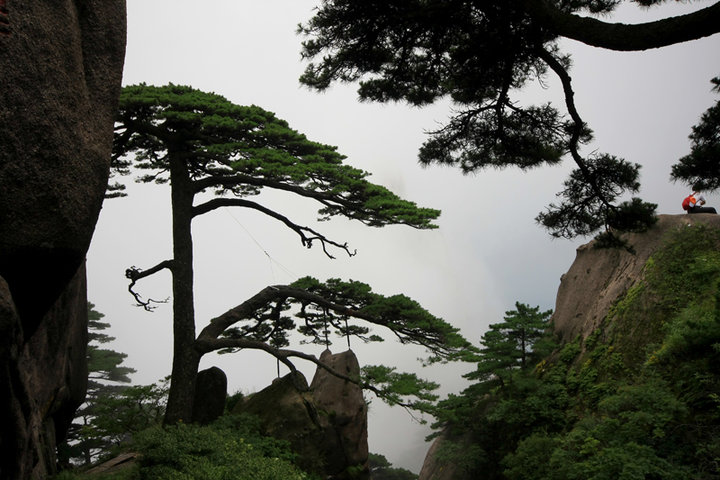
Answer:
[{"left": 0, "top": 265, "right": 88, "bottom": 479}]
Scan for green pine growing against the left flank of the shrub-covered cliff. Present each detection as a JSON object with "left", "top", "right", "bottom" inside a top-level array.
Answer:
[{"left": 432, "top": 302, "right": 573, "bottom": 479}]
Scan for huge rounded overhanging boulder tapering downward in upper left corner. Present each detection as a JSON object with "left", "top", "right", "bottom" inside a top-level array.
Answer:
[{"left": 0, "top": 0, "right": 125, "bottom": 328}]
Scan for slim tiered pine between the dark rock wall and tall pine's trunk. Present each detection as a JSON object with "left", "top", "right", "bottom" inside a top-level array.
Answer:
[{"left": 60, "top": 302, "right": 135, "bottom": 464}]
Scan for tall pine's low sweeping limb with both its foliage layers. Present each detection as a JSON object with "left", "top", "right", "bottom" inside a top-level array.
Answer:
[{"left": 194, "top": 277, "right": 476, "bottom": 411}]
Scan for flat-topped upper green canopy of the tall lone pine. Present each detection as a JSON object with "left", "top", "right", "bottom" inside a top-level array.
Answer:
[{"left": 114, "top": 84, "right": 440, "bottom": 236}]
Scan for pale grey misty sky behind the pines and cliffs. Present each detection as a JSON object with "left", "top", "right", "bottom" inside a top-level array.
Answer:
[{"left": 88, "top": 0, "right": 720, "bottom": 472}]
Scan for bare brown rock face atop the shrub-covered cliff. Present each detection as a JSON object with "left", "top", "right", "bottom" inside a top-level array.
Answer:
[{"left": 553, "top": 214, "right": 720, "bottom": 341}]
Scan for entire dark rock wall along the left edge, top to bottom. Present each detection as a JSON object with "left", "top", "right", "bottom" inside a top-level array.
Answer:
[{"left": 0, "top": 0, "right": 125, "bottom": 480}]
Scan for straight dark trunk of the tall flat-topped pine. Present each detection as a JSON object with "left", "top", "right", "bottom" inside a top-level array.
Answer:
[{"left": 165, "top": 153, "right": 201, "bottom": 424}]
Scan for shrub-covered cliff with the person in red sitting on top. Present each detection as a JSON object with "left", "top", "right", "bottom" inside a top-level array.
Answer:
[{"left": 419, "top": 214, "right": 720, "bottom": 480}]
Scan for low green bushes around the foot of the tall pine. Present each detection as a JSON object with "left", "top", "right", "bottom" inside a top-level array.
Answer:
[{"left": 56, "top": 390, "right": 417, "bottom": 480}]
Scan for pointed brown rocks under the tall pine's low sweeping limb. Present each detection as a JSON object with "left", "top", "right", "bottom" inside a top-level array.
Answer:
[{"left": 233, "top": 350, "right": 368, "bottom": 479}]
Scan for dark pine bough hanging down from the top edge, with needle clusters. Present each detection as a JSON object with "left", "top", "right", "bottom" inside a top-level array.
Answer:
[{"left": 300, "top": 0, "right": 720, "bottom": 238}]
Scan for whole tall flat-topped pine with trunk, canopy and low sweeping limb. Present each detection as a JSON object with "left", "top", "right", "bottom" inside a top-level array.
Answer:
[{"left": 114, "top": 84, "right": 468, "bottom": 423}]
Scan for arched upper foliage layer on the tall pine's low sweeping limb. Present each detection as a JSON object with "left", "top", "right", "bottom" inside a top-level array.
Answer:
[{"left": 197, "top": 277, "right": 474, "bottom": 363}]
